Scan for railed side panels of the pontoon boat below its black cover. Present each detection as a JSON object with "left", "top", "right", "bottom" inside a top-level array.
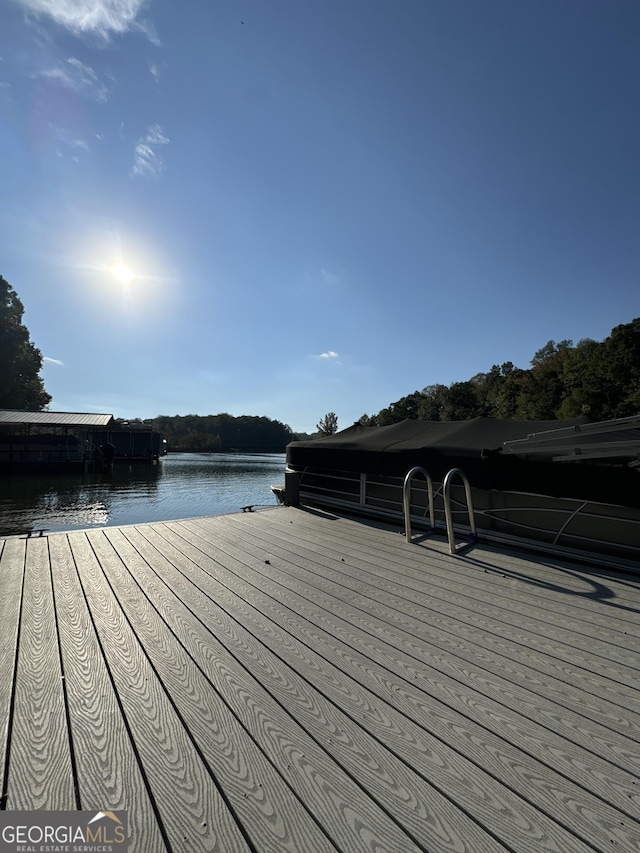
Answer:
[{"left": 285, "top": 466, "right": 640, "bottom": 571}]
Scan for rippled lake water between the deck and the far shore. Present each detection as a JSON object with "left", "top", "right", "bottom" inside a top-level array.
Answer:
[{"left": 0, "top": 453, "right": 285, "bottom": 536}]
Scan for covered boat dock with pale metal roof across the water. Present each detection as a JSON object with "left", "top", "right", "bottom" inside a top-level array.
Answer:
[{"left": 0, "top": 409, "right": 166, "bottom": 474}]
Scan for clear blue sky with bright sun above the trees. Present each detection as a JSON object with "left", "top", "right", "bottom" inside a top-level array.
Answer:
[{"left": 0, "top": 0, "right": 640, "bottom": 432}]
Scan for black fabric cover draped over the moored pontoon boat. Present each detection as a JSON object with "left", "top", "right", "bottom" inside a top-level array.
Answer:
[{"left": 287, "top": 416, "right": 640, "bottom": 506}]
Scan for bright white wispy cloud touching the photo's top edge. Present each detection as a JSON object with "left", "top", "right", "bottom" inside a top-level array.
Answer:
[{"left": 14, "top": 0, "right": 157, "bottom": 41}]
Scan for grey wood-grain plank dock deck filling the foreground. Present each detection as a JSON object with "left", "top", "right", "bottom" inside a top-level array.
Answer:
[{"left": 0, "top": 507, "right": 640, "bottom": 853}]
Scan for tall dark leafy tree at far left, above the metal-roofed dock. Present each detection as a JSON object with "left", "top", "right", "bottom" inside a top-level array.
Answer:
[{"left": 0, "top": 275, "right": 51, "bottom": 411}]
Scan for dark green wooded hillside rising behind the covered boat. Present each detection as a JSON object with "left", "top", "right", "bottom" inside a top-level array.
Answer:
[{"left": 359, "top": 318, "right": 640, "bottom": 426}]
